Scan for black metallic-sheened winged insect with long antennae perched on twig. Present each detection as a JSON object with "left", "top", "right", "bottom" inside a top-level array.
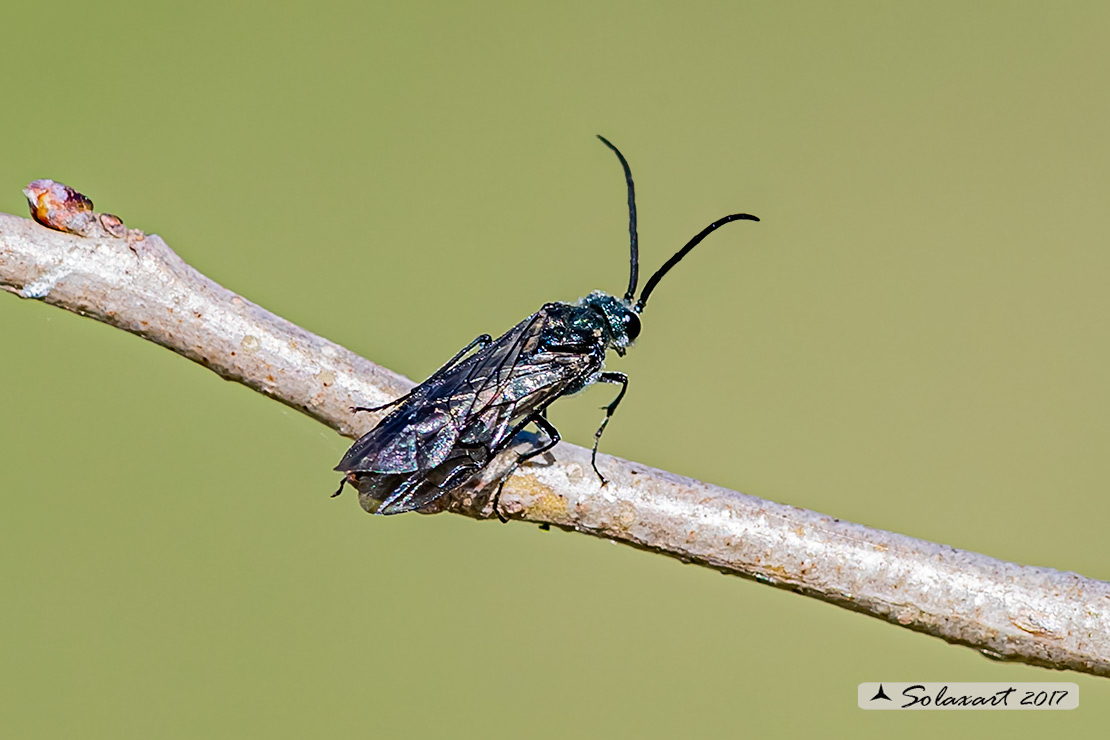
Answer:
[{"left": 334, "top": 136, "right": 758, "bottom": 518}]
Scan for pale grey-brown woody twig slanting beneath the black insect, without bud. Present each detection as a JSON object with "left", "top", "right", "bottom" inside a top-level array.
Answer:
[{"left": 0, "top": 207, "right": 1110, "bottom": 676}]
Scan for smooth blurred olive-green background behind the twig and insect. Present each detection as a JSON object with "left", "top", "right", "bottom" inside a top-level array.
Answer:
[{"left": 0, "top": 1, "right": 1110, "bottom": 738}]
